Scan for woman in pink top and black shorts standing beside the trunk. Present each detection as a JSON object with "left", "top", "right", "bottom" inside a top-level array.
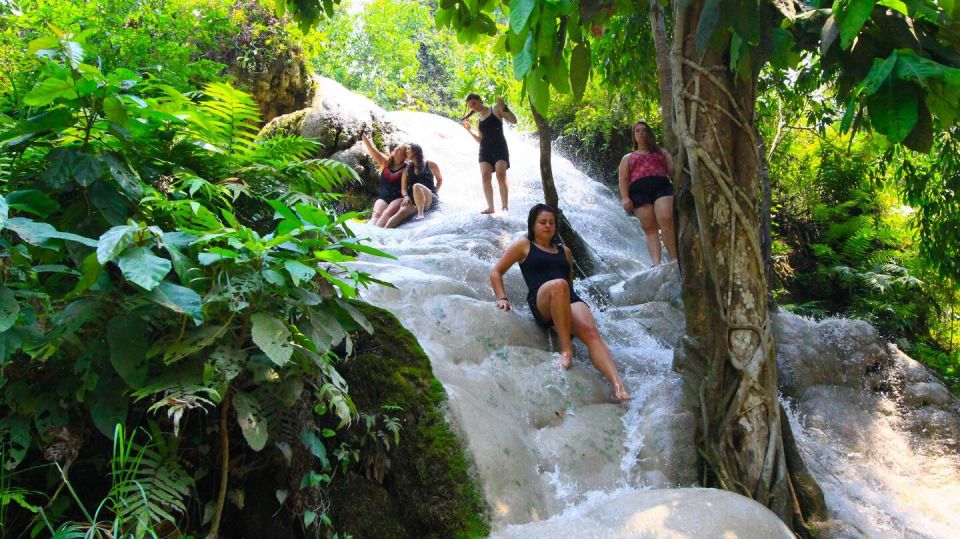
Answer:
[{"left": 620, "top": 120, "right": 677, "bottom": 266}]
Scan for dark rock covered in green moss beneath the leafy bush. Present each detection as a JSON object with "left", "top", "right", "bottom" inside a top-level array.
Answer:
[{"left": 330, "top": 303, "right": 490, "bottom": 539}]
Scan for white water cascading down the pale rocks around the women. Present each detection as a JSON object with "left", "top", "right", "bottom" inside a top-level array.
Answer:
[{"left": 322, "top": 81, "right": 960, "bottom": 537}]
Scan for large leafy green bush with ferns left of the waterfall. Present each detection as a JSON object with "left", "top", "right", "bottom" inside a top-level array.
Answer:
[{"left": 0, "top": 27, "right": 386, "bottom": 536}]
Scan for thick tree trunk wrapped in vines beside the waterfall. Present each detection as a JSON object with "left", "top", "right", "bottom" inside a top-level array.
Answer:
[{"left": 671, "top": 0, "right": 797, "bottom": 526}]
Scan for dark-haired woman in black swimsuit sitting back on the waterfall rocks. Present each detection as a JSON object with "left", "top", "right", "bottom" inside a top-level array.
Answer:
[{"left": 490, "top": 204, "right": 630, "bottom": 400}]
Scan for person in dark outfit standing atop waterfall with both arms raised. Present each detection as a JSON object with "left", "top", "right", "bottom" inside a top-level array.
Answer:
[{"left": 460, "top": 94, "right": 517, "bottom": 214}]
